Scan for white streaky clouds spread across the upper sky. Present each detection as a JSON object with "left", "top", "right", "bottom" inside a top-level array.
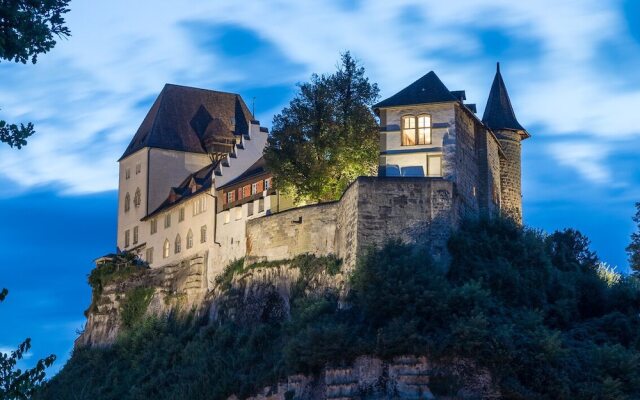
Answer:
[{"left": 0, "top": 0, "right": 640, "bottom": 193}]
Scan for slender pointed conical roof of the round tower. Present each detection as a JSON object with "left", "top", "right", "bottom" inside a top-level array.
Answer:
[{"left": 482, "top": 63, "right": 528, "bottom": 135}]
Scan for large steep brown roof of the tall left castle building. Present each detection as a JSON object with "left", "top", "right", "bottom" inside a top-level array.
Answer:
[{"left": 120, "top": 84, "right": 253, "bottom": 160}]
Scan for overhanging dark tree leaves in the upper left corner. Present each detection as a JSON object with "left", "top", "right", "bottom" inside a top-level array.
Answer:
[{"left": 0, "top": 0, "right": 71, "bottom": 149}]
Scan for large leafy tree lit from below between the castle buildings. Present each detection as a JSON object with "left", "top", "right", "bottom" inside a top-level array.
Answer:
[{"left": 264, "top": 52, "right": 379, "bottom": 201}]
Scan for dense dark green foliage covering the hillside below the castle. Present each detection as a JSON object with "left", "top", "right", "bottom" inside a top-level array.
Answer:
[{"left": 39, "top": 220, "right": 640, "bottom": 400}]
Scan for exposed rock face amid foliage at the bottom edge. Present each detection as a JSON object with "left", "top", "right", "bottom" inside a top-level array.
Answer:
[{"left": 228, "top": 356, "right": 500, "bottom": 400}]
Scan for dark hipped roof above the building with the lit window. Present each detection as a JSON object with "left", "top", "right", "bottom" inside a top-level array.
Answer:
[{"left": 373, "top": 71, "right": 462, "bottom": 109}]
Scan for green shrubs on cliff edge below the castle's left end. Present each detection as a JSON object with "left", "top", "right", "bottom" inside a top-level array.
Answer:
[{"left": 85, "top": 253, "right": 149, "bottom": 315}]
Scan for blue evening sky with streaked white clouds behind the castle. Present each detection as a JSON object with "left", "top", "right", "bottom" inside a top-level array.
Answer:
[{"left": 0, "top": 0, "right": 640, "bottom": 373}]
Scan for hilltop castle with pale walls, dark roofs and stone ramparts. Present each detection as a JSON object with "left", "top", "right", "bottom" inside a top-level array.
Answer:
[{"left": 117, "top": 65, "right": 529, "bottom": 285}]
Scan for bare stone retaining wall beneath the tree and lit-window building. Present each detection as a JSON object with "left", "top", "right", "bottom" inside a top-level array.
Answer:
[{"left": 246, "top": 177, "right": 460, "bottom": 269}]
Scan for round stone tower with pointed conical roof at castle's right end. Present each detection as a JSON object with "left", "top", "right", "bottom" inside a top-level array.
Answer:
[{"left": 482, "top": 63, "right": 530, "bottom": 223}]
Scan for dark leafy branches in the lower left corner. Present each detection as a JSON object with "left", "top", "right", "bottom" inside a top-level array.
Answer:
[{"left": 0, "top": 289, "right": 56, "bottom": 400}]
